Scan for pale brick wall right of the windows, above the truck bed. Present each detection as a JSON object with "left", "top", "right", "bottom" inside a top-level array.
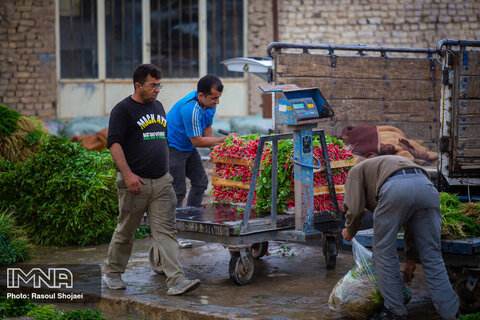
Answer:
[{"left": 248, "top": 0, "right": 480, "bottom": 113}]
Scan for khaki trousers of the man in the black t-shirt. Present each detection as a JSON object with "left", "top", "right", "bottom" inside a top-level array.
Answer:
[{"left": 104, "top": 173, "right": 185, "bottom": 288}]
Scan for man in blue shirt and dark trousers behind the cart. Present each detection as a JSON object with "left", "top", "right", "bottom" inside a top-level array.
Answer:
[{"left": 167, "top": 75, "right": 236, "bottom": 208}]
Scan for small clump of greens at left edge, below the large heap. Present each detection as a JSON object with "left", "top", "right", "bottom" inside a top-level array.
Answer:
[{"left": 0, "top": 209, "right": 30, "bottom": 266}]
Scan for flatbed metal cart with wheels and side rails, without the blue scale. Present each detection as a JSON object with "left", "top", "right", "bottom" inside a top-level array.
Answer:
[{"left": 142, "top": 130, "right": 343, "bottom": 285}]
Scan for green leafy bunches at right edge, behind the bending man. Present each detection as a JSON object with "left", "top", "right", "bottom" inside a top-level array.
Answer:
[{"left": 440, "top": 192, "right": 480, "bottom": 239}]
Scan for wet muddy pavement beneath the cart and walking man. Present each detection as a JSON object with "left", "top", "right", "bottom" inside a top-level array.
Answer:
[{"left": 24, "top": 239, "right": 440, "bottom": 320}]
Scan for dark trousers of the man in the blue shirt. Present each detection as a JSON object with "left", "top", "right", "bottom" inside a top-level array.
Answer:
[{"left": 168, "top": 147, "right": 208, "bottom": 208}]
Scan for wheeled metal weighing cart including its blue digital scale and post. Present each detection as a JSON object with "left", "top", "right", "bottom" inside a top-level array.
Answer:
[{"left": 144, "top": 85, "right": 348, "bottom": 285}]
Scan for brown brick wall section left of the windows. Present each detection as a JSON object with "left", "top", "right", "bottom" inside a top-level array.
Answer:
[{"left": 0, "top": 0, "right": 57, "bottom": 120}]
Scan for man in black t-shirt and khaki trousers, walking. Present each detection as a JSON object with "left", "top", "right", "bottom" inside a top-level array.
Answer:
[{"left": 103, "top": 64, "right": 200, "bottom": 295}]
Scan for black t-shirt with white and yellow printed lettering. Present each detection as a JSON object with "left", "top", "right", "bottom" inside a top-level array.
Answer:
[{"left": 107, "top": 97, "right": 168, "bottom": 179}]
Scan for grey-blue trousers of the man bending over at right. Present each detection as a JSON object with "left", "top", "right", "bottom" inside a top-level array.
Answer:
[{"left": 373, "top": 173, "right": 458, "bottom": 320}]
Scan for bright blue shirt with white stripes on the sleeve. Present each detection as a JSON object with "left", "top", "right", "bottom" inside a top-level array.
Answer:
[{"left": 167, "top": 91, "right": 217, "bottom": 151}]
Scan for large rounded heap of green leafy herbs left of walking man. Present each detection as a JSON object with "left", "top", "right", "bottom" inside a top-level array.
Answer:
[{"left": 0, "top": 136, "right": 118, "bottom": 246}]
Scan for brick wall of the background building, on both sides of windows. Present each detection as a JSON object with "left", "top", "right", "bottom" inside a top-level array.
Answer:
[{"left": 0, "top": 0, "right": 480, "bottom": 120}]
